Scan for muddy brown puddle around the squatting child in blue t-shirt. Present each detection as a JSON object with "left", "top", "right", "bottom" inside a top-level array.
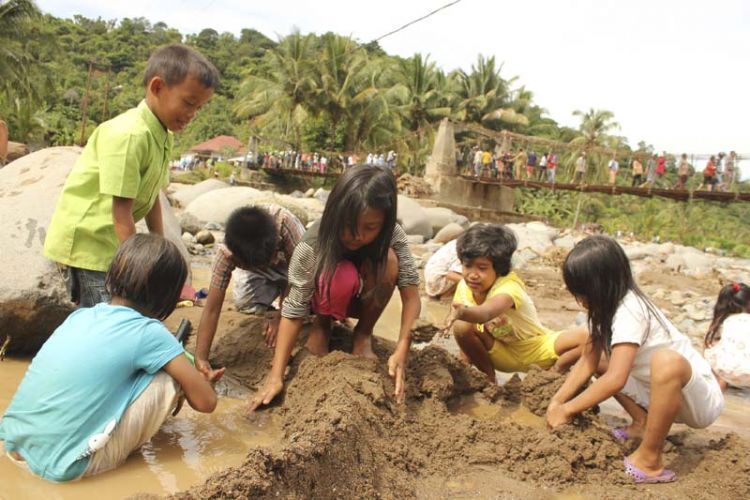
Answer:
[{"left": 0, "top": 359, "right": 282, "bottom": 500}]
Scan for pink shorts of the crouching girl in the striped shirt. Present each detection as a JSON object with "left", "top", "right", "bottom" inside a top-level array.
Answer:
[{"left": 312, "top": 260, "right": 362, "bottom": 321}]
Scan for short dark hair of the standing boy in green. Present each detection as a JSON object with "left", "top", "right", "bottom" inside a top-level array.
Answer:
[{"left": 143, "top": 44, "right": 219, "bottom": 89}]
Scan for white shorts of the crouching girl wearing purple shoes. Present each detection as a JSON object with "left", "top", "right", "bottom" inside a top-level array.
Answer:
[{"left": 622, "top": 359, "right": 724, "bottom": 429}]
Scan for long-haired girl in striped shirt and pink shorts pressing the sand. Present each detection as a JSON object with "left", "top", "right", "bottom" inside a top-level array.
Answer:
[{"left": 250, "top": 165, "right": 421, "bottom": 410}]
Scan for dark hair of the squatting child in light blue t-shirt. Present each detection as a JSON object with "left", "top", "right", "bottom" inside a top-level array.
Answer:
[{"left": 104, "top": 234, "right": 188, "bottom": 320}]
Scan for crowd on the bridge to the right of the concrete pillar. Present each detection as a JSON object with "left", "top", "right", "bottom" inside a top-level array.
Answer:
[{"left": 456, "top": 146, "right": 740, "bottom": 192}]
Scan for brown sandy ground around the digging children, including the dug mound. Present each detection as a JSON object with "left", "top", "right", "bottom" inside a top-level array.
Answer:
[{"left": 163, "top": 254, "right": 750, "bottom": 498}]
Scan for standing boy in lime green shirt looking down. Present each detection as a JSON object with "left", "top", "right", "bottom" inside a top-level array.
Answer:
[{"left": 44, "top": 45, "right": 219, "bottom": 307}]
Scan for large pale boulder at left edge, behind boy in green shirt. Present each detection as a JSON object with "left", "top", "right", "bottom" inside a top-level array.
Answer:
[{"left": 0, "top": 147, "right": 81, "bottom": 354}]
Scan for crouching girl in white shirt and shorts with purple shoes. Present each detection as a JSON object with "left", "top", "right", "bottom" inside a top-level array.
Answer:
[{"left": 547, "top": 236, "right": 724, "bottom": 484}]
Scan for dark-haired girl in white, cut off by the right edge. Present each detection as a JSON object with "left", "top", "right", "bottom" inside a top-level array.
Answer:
[{"left": 703, "top": 283, "right": 750, "bottom": 389}]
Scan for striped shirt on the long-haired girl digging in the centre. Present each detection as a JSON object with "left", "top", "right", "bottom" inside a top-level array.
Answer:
[{"left": 281, "top": 223, "right": 419, "bottom": 319}]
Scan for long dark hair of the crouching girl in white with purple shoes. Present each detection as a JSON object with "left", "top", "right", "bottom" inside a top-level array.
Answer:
[{"left": 562, "top": 235, "right": 669, "bottom": 355}]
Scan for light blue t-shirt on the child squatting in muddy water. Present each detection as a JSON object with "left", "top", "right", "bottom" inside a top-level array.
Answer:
[{"left": 0, "top": 304, "right": 183, "bottom": 481}]
